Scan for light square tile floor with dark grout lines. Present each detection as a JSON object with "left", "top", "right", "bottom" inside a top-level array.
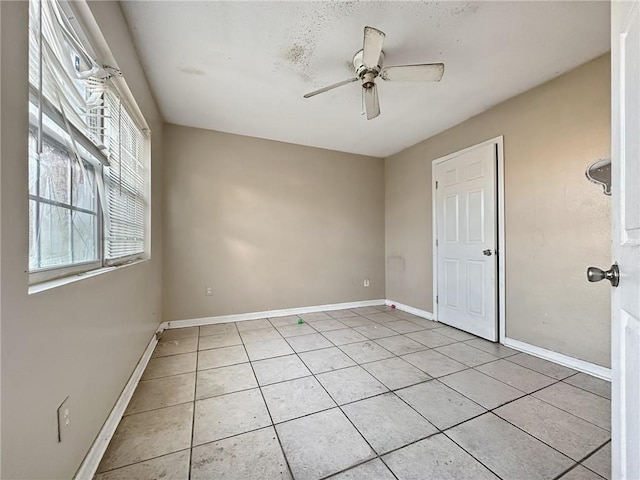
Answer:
[{"left": 96, "top": 307, "right": 611, "bottom": 480}]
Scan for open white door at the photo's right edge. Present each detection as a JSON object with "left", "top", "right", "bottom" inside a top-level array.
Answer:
[{"left": 611, "top": 0, "right": 640, "bottom": 479}]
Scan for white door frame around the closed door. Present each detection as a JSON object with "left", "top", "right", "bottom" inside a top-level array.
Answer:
[{"left": 431, "top": 135, "right": 506, "bottom": 343}]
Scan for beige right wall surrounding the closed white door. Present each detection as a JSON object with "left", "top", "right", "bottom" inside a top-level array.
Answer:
[{"left": 385, "top": 55, "right": 611, "bottom": 366}]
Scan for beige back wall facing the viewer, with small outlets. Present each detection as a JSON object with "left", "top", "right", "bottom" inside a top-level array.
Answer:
[{"left": 163, "top": 125, "right": 384, "bottom": 320}]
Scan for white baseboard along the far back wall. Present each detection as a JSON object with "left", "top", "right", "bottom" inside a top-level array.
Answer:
[{"left": 160, "top": 300, "right": 385, "bottom": 330}]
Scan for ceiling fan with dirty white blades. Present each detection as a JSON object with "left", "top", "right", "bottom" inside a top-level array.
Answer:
[{"left": 304, "top": 27, "right": 444, "bottom": 120}]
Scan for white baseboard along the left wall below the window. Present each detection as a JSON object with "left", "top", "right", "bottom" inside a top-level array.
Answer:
[{"left": 73, "top": 330, "right": 159, "bottom": 480}]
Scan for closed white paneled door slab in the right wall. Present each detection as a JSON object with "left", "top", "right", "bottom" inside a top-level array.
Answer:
[{"left": 434, "top": 143, "right": 498, "bottom": 342}]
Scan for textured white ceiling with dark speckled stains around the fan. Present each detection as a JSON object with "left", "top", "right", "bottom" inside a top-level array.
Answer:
[{"left": 122, "top": 1, "right": 610, "bottom": 157}]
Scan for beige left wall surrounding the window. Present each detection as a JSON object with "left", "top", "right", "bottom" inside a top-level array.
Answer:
[{"left": 0, "top": 2, "right": 163, "bottom": 479}]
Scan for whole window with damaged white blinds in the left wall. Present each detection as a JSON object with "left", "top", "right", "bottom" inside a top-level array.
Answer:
[{"left": 28, "top": 0, "right": 149, "bottom": 283}]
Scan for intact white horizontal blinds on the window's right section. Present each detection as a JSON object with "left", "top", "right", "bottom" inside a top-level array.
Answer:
[{"left": 105, "top": 92, "right": 147, "bottom": 263}]
